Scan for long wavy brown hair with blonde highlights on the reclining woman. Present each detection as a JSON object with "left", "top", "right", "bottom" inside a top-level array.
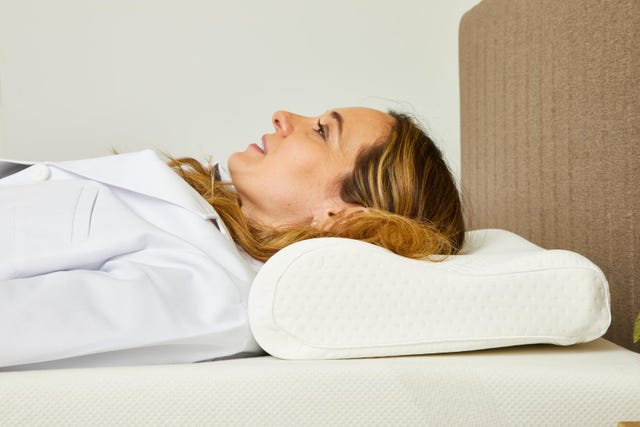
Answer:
[{"left": 168, "top": 111, "right": 465, "bottom": 261}]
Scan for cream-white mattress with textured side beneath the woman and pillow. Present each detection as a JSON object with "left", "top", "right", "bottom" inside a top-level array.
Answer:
[{"left": 0, "top": 339, "right": 640, "bottom": 426}]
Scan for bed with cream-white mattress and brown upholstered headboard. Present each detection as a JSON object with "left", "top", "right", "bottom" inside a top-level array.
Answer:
[{"left": 0, "top": 0, "right": 640, "bottom": 426}]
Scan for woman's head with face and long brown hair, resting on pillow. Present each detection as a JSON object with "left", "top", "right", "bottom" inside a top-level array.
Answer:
[{"left": 170, "top": 108, "right": 465, "bottom": 260}]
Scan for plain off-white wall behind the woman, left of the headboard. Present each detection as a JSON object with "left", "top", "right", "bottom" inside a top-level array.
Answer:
[{"left": 0, "top": 0, "right": 477, "bottom": 179}]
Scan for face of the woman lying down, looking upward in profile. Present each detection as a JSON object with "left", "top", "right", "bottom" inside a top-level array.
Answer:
[{"left": 229, "top": 107, "right": 394, "bottom": 227}]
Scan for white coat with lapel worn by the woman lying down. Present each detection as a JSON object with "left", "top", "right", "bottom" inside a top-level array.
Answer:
[{"left": 0, "top": 150, "right": 261, "bottom": 369}]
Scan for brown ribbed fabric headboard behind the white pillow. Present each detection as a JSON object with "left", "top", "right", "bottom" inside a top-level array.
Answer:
[{"left": 460, "top": 0, "right": 640, "bottom": 351}]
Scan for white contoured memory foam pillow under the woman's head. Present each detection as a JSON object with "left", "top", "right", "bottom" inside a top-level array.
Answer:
[{"left": 249, "top": 229, "right": 611, "bottom": 359}]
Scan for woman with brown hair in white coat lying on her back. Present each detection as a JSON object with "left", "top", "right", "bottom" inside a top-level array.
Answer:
[{"left": 0, "top": 108, "right": 464, "bottom": 369}]
